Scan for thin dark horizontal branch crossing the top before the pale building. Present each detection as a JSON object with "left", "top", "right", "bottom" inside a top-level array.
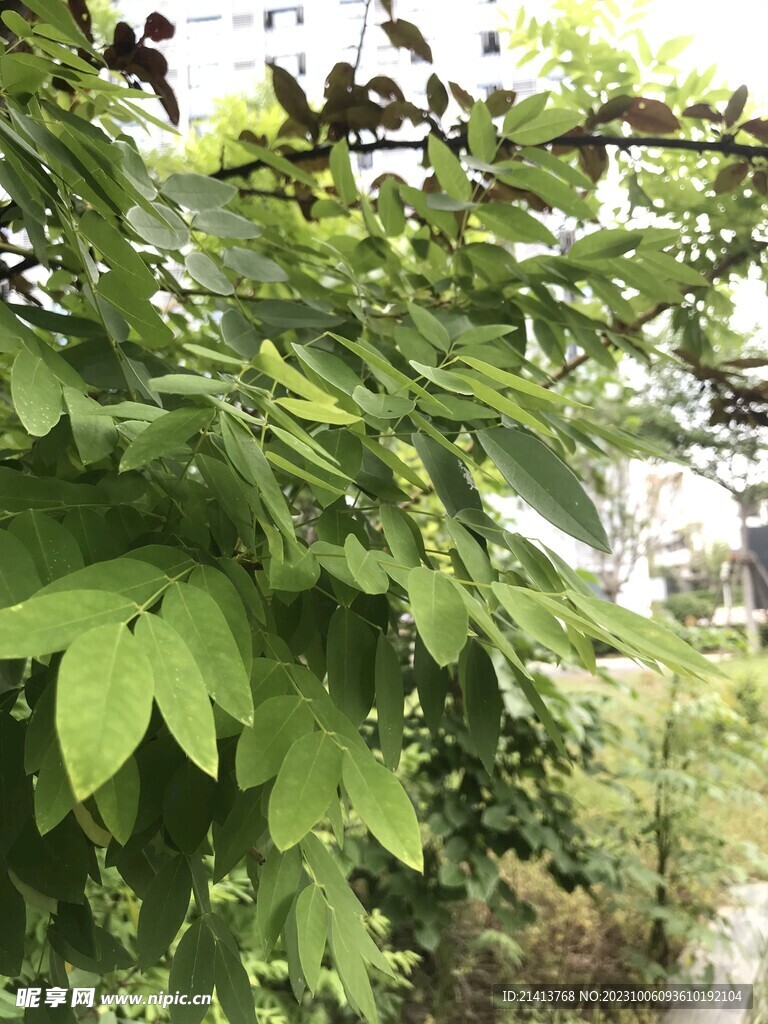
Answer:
[{"left": 211, "top": 135, "right": 768, "bottom": 178}]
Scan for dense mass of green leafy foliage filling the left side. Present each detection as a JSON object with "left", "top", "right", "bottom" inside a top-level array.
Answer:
[{"left": 0, "top": 0, "right": 765, "bottom": 1024}]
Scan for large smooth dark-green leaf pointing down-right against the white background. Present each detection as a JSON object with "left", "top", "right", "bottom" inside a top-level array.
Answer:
[{"left": 477, "top": 427, "right": 610, "bottom": 553}]
